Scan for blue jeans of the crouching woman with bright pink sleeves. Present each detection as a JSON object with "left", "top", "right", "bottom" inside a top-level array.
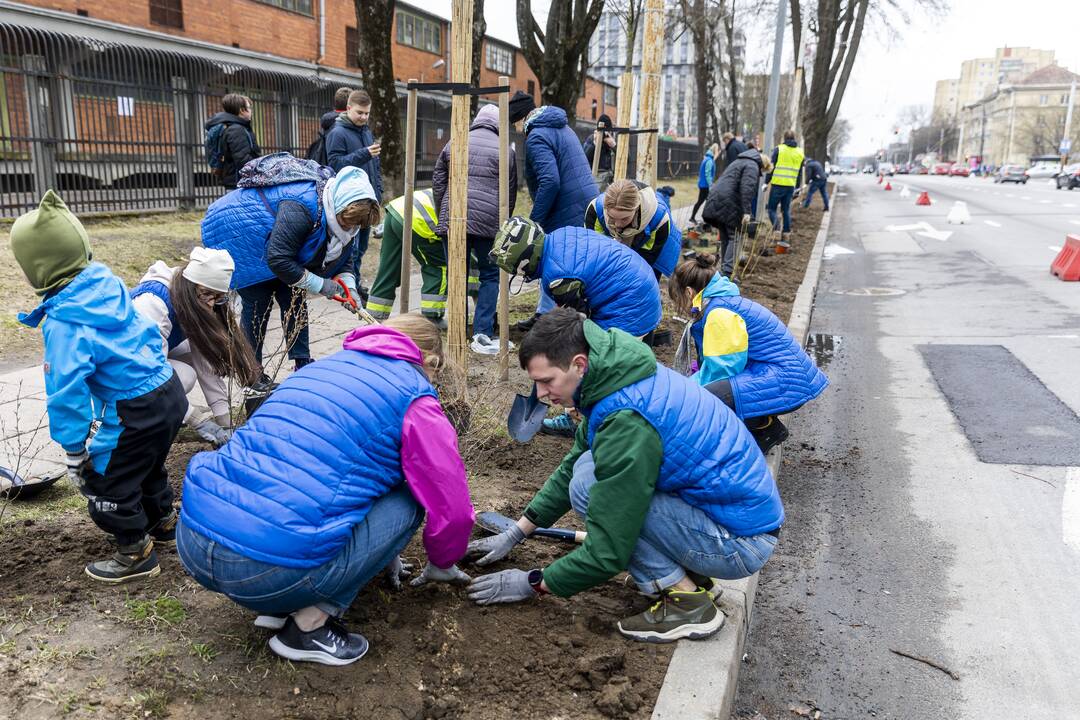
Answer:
[{"left": 176, "top": 486, "right": 423, "bottom": 617}]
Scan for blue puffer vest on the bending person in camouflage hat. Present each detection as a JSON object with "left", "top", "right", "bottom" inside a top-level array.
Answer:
[{"left": 539, "top": 227, "right": 662, "bottom": 337}]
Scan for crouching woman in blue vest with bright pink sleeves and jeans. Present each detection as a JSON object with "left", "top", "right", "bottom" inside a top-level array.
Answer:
[{"left": 177, "top": 314, "right": 474, "bottom": 665}]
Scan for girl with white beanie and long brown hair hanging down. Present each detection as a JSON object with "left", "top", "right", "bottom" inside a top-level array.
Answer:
[{"left": 132, "top": 247, "right": 260, "bottom": 447}]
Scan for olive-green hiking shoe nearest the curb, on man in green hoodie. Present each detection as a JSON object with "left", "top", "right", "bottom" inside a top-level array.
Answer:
[{"left": 619, "top": 587, "right": 724, "bottom": 642}]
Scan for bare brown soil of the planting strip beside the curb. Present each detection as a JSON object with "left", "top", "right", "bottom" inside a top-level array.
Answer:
[{"left": 0, "top": 199, "right": 821, "bottom": 720}]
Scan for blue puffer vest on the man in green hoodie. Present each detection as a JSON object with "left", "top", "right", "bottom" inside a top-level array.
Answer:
[{"left": 580, "top": 363, "right": 784, "bottom": 535}]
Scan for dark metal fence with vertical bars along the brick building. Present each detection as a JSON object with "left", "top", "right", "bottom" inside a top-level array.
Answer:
[{"left": 0, "top": 24, "right": 699, "bottom": 217}]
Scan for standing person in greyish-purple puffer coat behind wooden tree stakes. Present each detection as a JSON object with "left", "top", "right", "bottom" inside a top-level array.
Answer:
[{"left": 431, "top": 105, "right": 517, "bottom": 355}]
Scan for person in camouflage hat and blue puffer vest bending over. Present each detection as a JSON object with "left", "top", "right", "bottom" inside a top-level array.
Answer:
[{"left": 491, "top": 216, "right": 663, "bottom": 437}]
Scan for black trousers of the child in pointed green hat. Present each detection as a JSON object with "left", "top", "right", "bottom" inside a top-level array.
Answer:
[{"left": 82, "top": 373, "right": 188, "bottom": 545}]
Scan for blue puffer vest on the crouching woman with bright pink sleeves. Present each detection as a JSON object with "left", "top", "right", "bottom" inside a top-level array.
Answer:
[{"left": 181, "top": 350, "right": 435, "bottom": 568}]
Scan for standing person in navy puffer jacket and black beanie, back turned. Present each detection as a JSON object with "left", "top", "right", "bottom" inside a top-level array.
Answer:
[{"left": 517, "top": 105, "right": 599, "bottom": 331}]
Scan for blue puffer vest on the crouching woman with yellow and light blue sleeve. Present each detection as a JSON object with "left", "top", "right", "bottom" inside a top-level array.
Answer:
[{"left": 690, "top": 295, "right": 828, "bottom": 418}]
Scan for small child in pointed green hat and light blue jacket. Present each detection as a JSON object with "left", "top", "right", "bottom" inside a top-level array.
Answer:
[{"left": 11, "top": 190, "right": 188, "bottom": 583}]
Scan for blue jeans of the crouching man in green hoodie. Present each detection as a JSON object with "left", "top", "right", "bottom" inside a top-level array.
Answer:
[{"left": 570, "top": 451, "right": 777, "bottom": 594}]
